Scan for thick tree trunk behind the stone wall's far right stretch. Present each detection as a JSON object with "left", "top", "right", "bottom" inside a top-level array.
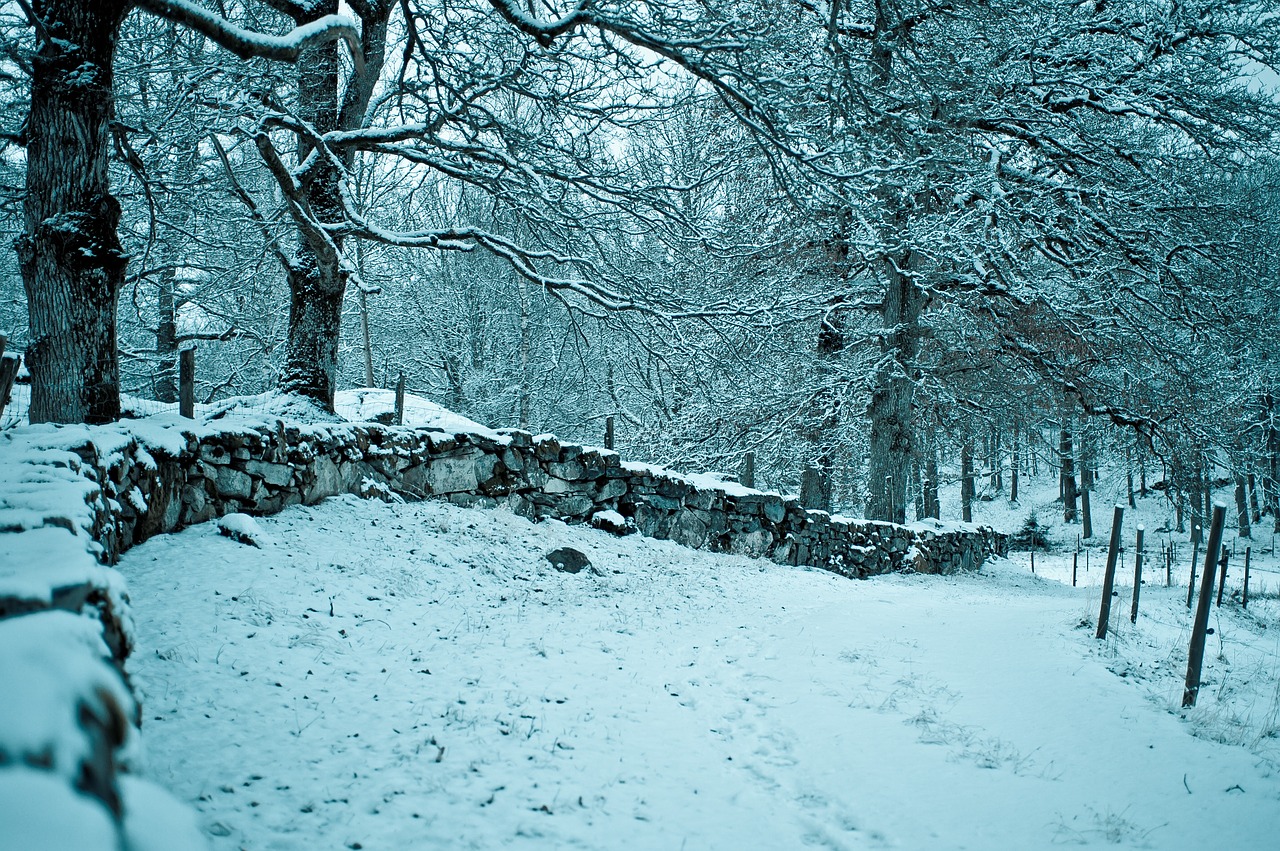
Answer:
[{"left": 867, "top": 253, "right": 924, "bottom": 523}]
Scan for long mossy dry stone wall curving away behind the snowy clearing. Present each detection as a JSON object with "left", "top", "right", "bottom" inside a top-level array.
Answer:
[{"left": 77, "top": 422, "right": 1004, "bottom": 577}]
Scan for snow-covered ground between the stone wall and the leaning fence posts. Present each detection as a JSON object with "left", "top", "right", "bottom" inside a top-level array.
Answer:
[{"left": 120, "top": 498, "right": 1280, "bottom": 850}]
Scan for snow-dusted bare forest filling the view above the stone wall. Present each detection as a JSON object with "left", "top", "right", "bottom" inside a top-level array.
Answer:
[{"left": 0, "top": 0, "right": 1280, "bottom": 521}]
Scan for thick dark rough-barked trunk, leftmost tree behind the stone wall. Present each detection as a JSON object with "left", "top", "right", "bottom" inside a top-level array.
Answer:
[{"left": 17, "top": 0, "right": 132, "bottom": 422}]
